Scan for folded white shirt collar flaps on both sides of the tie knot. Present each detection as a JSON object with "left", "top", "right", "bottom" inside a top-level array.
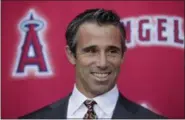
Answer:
[{"left": 69, "top": 85, "right": 119, "bottom": 115}]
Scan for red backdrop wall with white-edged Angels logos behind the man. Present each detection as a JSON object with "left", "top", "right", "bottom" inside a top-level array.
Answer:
[{"left": 1, "top": 1, "right": 185, "bottom": 118}]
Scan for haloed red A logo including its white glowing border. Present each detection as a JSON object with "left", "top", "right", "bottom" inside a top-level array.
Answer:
[{"left": 13, "top": 10, "right": 52, "bottom": 76}]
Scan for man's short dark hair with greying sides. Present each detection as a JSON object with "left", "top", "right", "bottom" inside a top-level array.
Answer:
[{"left": 65, "top": 8, "right": 126, "bottom": 55}]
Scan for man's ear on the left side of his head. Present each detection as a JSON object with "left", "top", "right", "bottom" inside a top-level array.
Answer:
[{"left": 65, "top": 46, "right": 76, "bottom": 65}]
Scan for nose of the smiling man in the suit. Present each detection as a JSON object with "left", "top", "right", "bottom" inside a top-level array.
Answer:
[{"left": 97, "top": 52, "right": 108, "bottom": 69}]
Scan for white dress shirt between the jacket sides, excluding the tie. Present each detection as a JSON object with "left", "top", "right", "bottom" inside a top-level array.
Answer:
[{"left": 67, "top": 85, "right": 119, "bottom": 119}]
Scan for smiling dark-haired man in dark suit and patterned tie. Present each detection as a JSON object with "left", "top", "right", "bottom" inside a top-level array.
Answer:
[{"left": 20, "top": 9, "right": 167, "bottom": 119}]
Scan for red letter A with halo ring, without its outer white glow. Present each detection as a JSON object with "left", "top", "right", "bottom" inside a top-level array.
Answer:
[{"left": 15, "top": 11, "right": 50, "bottom": 77}]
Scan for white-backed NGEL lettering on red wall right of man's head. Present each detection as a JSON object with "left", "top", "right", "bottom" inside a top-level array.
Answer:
[{"left": 121, "top": 15, "right": 184, "bottom": 49}]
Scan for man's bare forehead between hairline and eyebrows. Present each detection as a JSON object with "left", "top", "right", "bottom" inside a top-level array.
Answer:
[{"left": 77, "top": 23, "right": 121, "bottom": 47}]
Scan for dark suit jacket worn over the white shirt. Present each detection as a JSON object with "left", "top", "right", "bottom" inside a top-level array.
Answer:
[{"left": 20, "top": 93, "right": 164, "bottom": 119}]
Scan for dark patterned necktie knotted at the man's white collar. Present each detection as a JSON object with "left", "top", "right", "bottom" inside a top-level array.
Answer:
[{"left": 84, "top": 100, "right": 98, "bottom": 119}]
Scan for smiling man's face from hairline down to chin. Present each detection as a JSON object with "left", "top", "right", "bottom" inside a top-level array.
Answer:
[{"left": 66, "top": 23, "right": 123, "bottom": 97}]
